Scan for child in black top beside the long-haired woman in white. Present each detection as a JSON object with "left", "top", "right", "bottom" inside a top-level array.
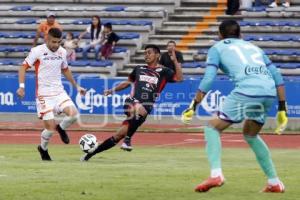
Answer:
[{"left": 101, "top": 23, "right": 120, "bottom": 60}]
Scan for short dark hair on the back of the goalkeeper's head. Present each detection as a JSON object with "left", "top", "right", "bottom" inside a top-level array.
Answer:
[{"left": 219, "top": 19, "right": 241, "bottom": 38}]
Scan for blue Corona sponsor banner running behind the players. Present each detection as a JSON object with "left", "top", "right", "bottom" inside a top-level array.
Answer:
[{"left": 0, "top": 74, "right": 300, "bottom": 117}]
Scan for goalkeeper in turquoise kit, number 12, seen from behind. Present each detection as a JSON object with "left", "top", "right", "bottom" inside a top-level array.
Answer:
[{"left": 182, "top": 20, "right": 288, "bottom": 192}]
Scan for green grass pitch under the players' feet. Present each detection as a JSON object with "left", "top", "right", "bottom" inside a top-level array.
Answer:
[{"left": 0, "top": 145, "right": 300, "bottom": 200}]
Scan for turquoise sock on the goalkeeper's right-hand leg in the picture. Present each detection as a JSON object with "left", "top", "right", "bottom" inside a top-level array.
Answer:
[{"left": 244, "top": 135, "right": 277, "bottom": 180}]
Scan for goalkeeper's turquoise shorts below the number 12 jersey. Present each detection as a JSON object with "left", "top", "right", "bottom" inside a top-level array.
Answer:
[{"left": 218, "top": 92, "right": 275, "bottom": 124}]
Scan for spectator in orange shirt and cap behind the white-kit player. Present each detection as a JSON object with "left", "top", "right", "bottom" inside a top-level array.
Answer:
[{"left": 33, "top": 12, "right": 62, "bottom": 47}]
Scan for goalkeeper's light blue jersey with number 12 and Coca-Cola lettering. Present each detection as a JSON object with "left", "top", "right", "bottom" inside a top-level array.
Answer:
[{"left": 199, "top": 38, "right": 283, "bottom": 97}]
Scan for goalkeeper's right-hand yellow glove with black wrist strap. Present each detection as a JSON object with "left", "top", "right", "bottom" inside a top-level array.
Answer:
[{"left": 275, "top": 101, "right": 288, "bottom": 135}]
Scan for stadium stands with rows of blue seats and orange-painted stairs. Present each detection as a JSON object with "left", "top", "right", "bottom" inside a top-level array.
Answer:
[{"left": 0, "top": 0, "right": 300, "bottom": 75}]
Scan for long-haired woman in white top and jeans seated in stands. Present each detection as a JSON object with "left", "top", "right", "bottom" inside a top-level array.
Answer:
[{"left": 79, "top": 15, "right": 103, "bottom": 60}]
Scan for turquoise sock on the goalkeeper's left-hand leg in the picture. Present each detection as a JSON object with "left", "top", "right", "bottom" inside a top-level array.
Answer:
[{"left": 204, "top": 127, "right": 223, "bottom": 177}]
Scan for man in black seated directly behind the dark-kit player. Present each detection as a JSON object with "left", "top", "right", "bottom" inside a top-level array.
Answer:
[{"left": 159, "top": 40, "right": 184, "bottom": 71}]
